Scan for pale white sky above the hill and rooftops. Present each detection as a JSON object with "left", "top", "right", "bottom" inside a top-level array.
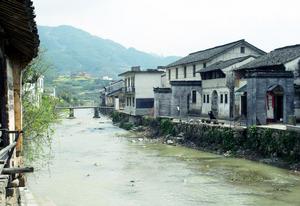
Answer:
[{"left": 33, "top": 0, "right": 300, "bottom": 56}]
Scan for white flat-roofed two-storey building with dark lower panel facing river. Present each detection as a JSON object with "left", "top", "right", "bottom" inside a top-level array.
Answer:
[{"left": 119, "top": 67, "right": 163, "bottom": 115}]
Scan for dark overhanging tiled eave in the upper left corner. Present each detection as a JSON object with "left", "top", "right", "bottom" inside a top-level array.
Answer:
[{"left": 0, "top": 0, "right": 40, "bottom": 63}]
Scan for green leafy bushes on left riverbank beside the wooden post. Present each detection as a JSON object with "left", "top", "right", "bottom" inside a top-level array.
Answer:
[{"left": 22, "top": 54, "right": 60, "bottom": 165}]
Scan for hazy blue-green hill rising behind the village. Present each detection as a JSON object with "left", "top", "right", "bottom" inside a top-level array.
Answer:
[{"left": 38, "top": 26, "right": 178, "bottom": 77}]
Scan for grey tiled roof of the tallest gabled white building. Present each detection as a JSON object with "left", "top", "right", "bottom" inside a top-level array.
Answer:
[{"left": 167, "top": 39, "right": 265, "bottom": 67}]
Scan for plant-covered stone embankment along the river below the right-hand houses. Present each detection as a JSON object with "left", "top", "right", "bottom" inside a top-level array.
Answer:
[{"left": 111, "top": 112, "right": 300, "bottom": 172}]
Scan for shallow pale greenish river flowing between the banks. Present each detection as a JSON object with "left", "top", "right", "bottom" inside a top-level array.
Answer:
[{"left": 28, "top": 111, "right": 300, "bottom": 206}]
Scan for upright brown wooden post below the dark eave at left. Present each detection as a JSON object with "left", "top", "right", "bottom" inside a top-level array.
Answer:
[{"left": 13, "top": 66, "right": 23, "bottom": 156}]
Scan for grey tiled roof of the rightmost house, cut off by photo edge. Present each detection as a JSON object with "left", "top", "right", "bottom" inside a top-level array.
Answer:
[{"left": 237, "top": 44, "right": 300, "bottom": 70}]
